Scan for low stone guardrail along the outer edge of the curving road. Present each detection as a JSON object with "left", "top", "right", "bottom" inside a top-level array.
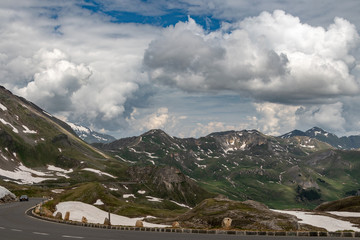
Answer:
[{"left": 26, "top": 207, "right": 360, "bottom": 238}]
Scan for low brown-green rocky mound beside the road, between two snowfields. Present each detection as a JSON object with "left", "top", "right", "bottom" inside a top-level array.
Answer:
[{"left": 175, "top": 198, "right": 299, "bottom": 231}]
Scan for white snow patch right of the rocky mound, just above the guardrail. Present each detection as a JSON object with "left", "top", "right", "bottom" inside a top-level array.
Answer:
[{"left": 272, "top": 210, "right": 360, "bottom": 232}]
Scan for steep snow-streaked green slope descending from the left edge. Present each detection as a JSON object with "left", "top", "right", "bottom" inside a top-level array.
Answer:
[{"left": 0, "top": 87, "right": 214, "bottom": 210}]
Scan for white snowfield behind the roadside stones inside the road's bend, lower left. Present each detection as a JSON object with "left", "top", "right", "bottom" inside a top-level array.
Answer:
[{"left": 54, "top": 201, "right": 170, "bottom": 228}]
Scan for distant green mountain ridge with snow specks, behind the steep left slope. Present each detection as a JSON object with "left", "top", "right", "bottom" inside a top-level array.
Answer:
[{"left": 96, "top": 130, "right": 360, "bottom": 208}]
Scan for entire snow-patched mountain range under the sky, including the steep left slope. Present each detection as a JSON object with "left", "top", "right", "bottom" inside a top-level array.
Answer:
[{"left": 0, "top": 85, "right": 360, "bottom": 212}]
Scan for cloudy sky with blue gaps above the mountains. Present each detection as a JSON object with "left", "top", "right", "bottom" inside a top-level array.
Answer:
[{"left": 0, "top": 0, "right": 360, "bottom": 138}]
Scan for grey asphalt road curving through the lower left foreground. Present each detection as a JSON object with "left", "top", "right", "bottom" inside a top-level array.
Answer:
[{"left": 0, "top": 199, "right": 352, "bottom": 240}]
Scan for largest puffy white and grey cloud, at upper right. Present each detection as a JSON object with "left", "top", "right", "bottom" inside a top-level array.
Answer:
[{"left": 144, "top": 10, "right": 359, "bottom": 103}]
